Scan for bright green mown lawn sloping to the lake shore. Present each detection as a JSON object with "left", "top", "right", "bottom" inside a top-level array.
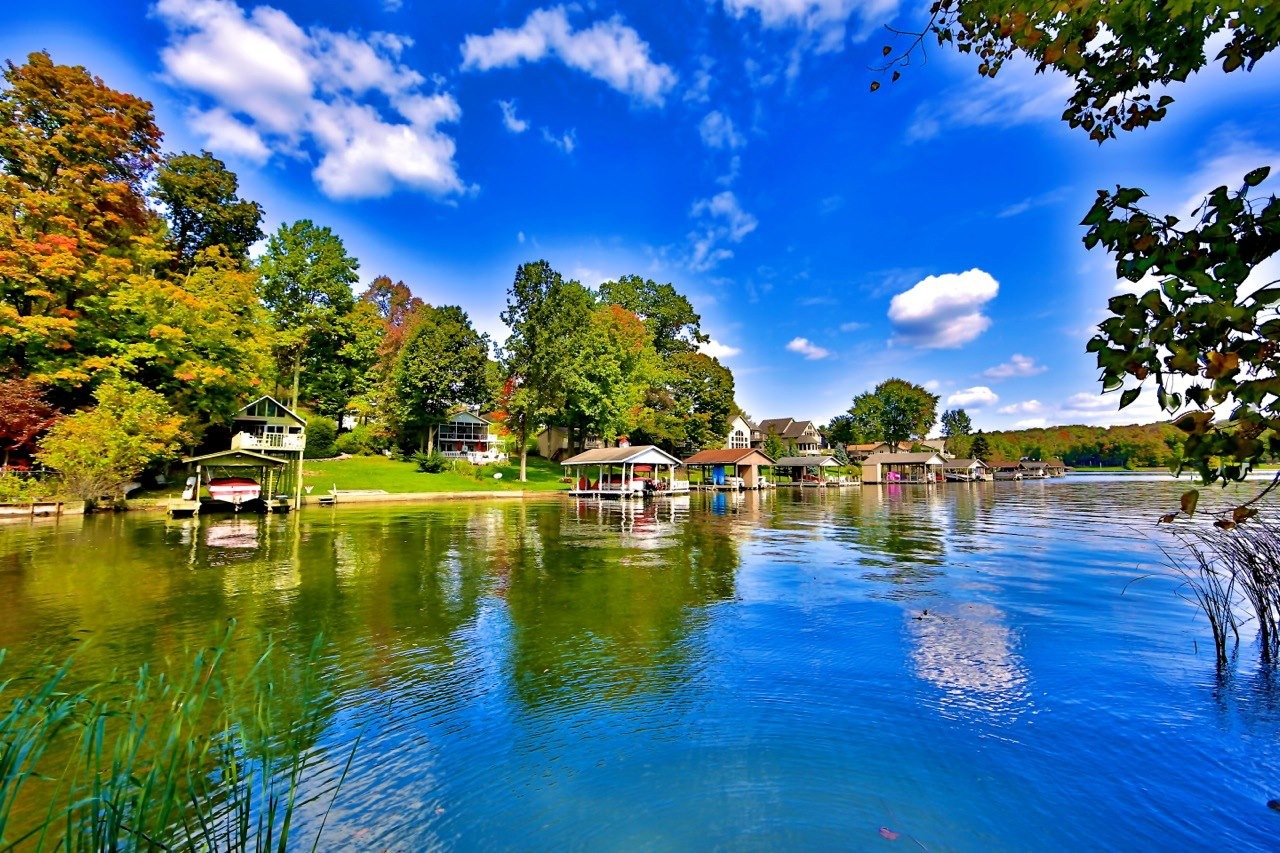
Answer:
[{"left": 302, "top": 456, "right": 568, "bottom": 494}]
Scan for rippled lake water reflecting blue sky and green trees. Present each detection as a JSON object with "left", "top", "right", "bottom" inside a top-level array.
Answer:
[{"left": 0, "top": 476, "right": 1280, "bottom": 850}]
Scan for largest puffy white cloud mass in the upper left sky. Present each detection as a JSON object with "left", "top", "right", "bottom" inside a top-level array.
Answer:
[{"left": 154, "top": 0, "right": 466, "bottom": 199}]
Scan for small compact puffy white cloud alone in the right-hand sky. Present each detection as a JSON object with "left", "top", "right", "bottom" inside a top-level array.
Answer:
[{"left": 888, "top": 269, "right": 1000, "bottom": 350}]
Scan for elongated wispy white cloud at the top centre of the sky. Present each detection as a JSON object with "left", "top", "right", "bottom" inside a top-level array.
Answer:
[{"left": 462, "top": 6, "right": 676, "bottom": 105}]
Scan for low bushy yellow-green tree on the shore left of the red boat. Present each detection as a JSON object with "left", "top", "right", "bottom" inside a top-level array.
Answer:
[{"left": 37, "top": 378, "right": 183, "bottom": 502}]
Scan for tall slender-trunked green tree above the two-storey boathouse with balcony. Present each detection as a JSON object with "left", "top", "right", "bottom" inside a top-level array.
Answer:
[{"left": 259, "top": 219, "right": 360, "bottom": 409}]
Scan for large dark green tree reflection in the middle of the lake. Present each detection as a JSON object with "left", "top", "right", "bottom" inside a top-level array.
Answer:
[{"left": 507, "top": 501, "right": 739, "bottom": 706}]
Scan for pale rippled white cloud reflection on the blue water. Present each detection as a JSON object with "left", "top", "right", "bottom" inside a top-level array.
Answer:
[{"left": 909, "top": 596, "right": 1030, "bottom": 722}]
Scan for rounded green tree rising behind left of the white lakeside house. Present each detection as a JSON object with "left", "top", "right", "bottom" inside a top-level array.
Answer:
[{"left": 389, "top": 305, "right": 489, "bottom": 453}]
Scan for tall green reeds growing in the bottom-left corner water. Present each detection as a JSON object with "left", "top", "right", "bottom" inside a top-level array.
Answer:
[{"left": 0, "top": 626, "right": 355, "bottom": 852}]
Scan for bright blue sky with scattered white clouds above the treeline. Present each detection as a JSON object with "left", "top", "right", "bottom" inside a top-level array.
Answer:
[{"left": 0, "top": 0, "right": 1280, "bottom": 429}]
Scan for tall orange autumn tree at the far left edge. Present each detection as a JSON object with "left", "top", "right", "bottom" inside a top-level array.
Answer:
[{"left": 0, "top": 53, "right": 161, "bottom": 388}]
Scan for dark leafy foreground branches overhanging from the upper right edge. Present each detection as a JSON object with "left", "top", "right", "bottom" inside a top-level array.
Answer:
[{"left": 872, "top": 0, "right": 1280, "bottom": 491}]
